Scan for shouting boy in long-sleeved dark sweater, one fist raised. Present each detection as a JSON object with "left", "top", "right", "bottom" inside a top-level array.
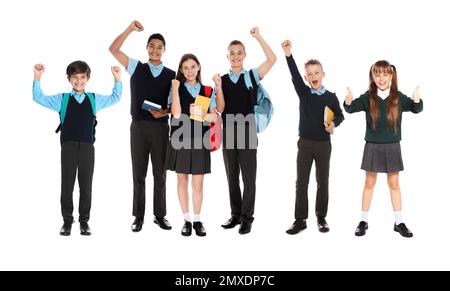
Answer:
[{"left": 281, "top": 40, "right": 344, "bottom": 235}]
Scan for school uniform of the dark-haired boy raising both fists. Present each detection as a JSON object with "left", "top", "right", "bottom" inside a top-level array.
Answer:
[{"left": 33, "top": 81, "right": 122, "bottom": 223}]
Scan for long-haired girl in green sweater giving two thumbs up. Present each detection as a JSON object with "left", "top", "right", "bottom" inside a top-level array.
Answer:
[{"left": 344, "top": 60, "right": 423, "bottom": 237}]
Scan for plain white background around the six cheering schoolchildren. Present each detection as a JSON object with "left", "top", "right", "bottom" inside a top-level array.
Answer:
[{"left": 0, "top": 0, "right": 450, "bottom": 270}]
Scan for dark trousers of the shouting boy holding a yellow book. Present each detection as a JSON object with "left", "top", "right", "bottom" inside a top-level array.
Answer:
[{"left": 295, "top": 138, "right": 331, "bottom": 219}]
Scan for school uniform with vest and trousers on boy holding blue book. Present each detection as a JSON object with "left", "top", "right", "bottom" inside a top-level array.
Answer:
[{"left": 127, "top": 58, "right": 175, "bottom": 218}]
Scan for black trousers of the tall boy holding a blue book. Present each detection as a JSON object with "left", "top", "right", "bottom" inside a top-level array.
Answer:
[{"left": 130, "top": 120, "right": 169, "bottom": 218}]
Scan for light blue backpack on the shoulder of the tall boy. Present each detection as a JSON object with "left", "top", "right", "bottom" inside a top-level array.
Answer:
[{"left": 244, "top": 72, "right": 274, "bottom": 133}]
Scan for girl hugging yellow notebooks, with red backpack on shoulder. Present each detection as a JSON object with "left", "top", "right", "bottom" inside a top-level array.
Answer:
[{"left": 166, "top": 54, "right": 218, "bottom": 236}]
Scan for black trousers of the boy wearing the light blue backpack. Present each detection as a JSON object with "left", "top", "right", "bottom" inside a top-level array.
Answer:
[{"left": 223, "top": 128, "right": 257, "bottom": 222}]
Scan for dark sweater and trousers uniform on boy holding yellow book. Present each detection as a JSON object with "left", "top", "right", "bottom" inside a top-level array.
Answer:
[{"left": 286, "top": 55, "right": 344, "bottom": 220}]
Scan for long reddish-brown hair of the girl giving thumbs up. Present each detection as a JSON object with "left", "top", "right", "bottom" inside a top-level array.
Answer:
[{"left": 369, "top": 61, "right": 398, "bottom": 132}]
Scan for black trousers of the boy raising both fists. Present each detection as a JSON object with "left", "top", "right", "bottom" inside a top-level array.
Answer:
[{"left": 61, "top": 142, "right": 95, "bottom": 223}]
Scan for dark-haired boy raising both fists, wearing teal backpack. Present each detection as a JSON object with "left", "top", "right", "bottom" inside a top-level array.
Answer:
[{"left": 33, "top": 61, "right": 122, "bottom": 236}]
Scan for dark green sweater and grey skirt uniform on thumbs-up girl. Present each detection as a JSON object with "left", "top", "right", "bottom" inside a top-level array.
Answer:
[{"left": 344, "top": 90, "right": 423, "bottom": 173}]
